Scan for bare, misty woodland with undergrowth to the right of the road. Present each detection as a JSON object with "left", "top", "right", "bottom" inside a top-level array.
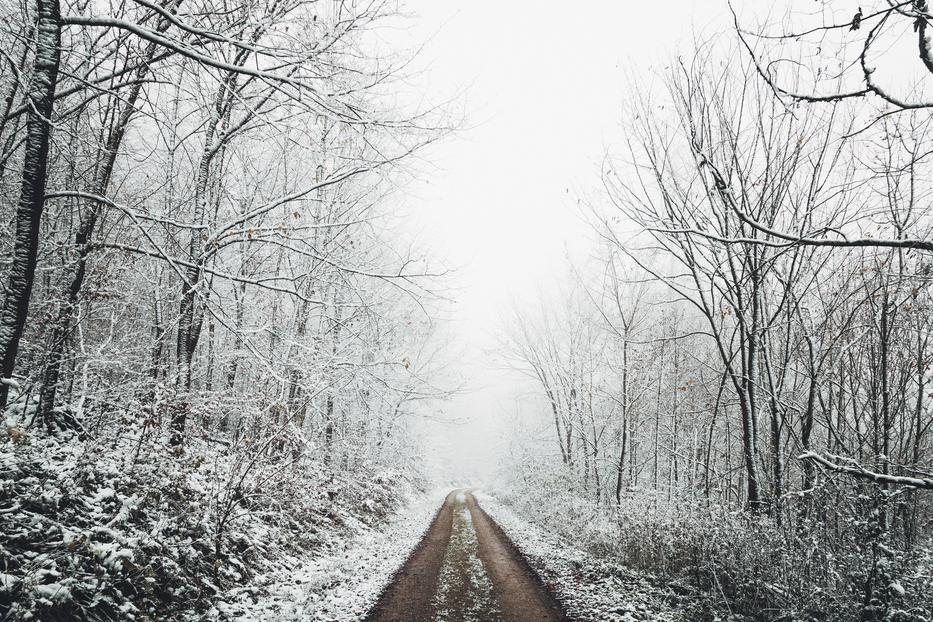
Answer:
[{"left": 503, "top": 1, "right": 933, "bottom": 620}]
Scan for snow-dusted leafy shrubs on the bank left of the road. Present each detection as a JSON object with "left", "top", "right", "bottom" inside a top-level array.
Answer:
[{"left": 0, "top": 426, "right": 416, "bottom": 620}]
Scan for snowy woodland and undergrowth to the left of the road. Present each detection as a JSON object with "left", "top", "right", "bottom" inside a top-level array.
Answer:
[{"left": 0, "top": 0, "right": 447, "bottom": 620}]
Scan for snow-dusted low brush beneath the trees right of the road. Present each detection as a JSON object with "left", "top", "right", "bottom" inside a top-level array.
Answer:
[{"left": 501, "top": 475, "right": 933, "bottom": 622}]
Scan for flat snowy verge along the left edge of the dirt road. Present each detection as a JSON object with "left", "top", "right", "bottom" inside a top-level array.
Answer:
[{"left": 219, "top": 489, "right": 450, "bottom": 622}]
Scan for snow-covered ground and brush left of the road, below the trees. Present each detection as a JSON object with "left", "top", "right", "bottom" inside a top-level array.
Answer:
[{"left": 0, "top": 427, "right": 441, "bottom": 622}]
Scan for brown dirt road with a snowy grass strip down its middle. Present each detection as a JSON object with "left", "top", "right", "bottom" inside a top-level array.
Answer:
[{"left": 366, "top": 490, "right": 567, "bottom": 622}]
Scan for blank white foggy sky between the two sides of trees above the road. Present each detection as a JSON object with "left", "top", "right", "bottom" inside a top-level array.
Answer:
[{"left": 390, "top": 0, "right": 740, "bottom": 483}]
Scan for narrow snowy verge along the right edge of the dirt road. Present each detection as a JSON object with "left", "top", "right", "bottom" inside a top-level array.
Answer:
[{"left": 475, "top": 492, "right": 685, "bottom": 622}]
